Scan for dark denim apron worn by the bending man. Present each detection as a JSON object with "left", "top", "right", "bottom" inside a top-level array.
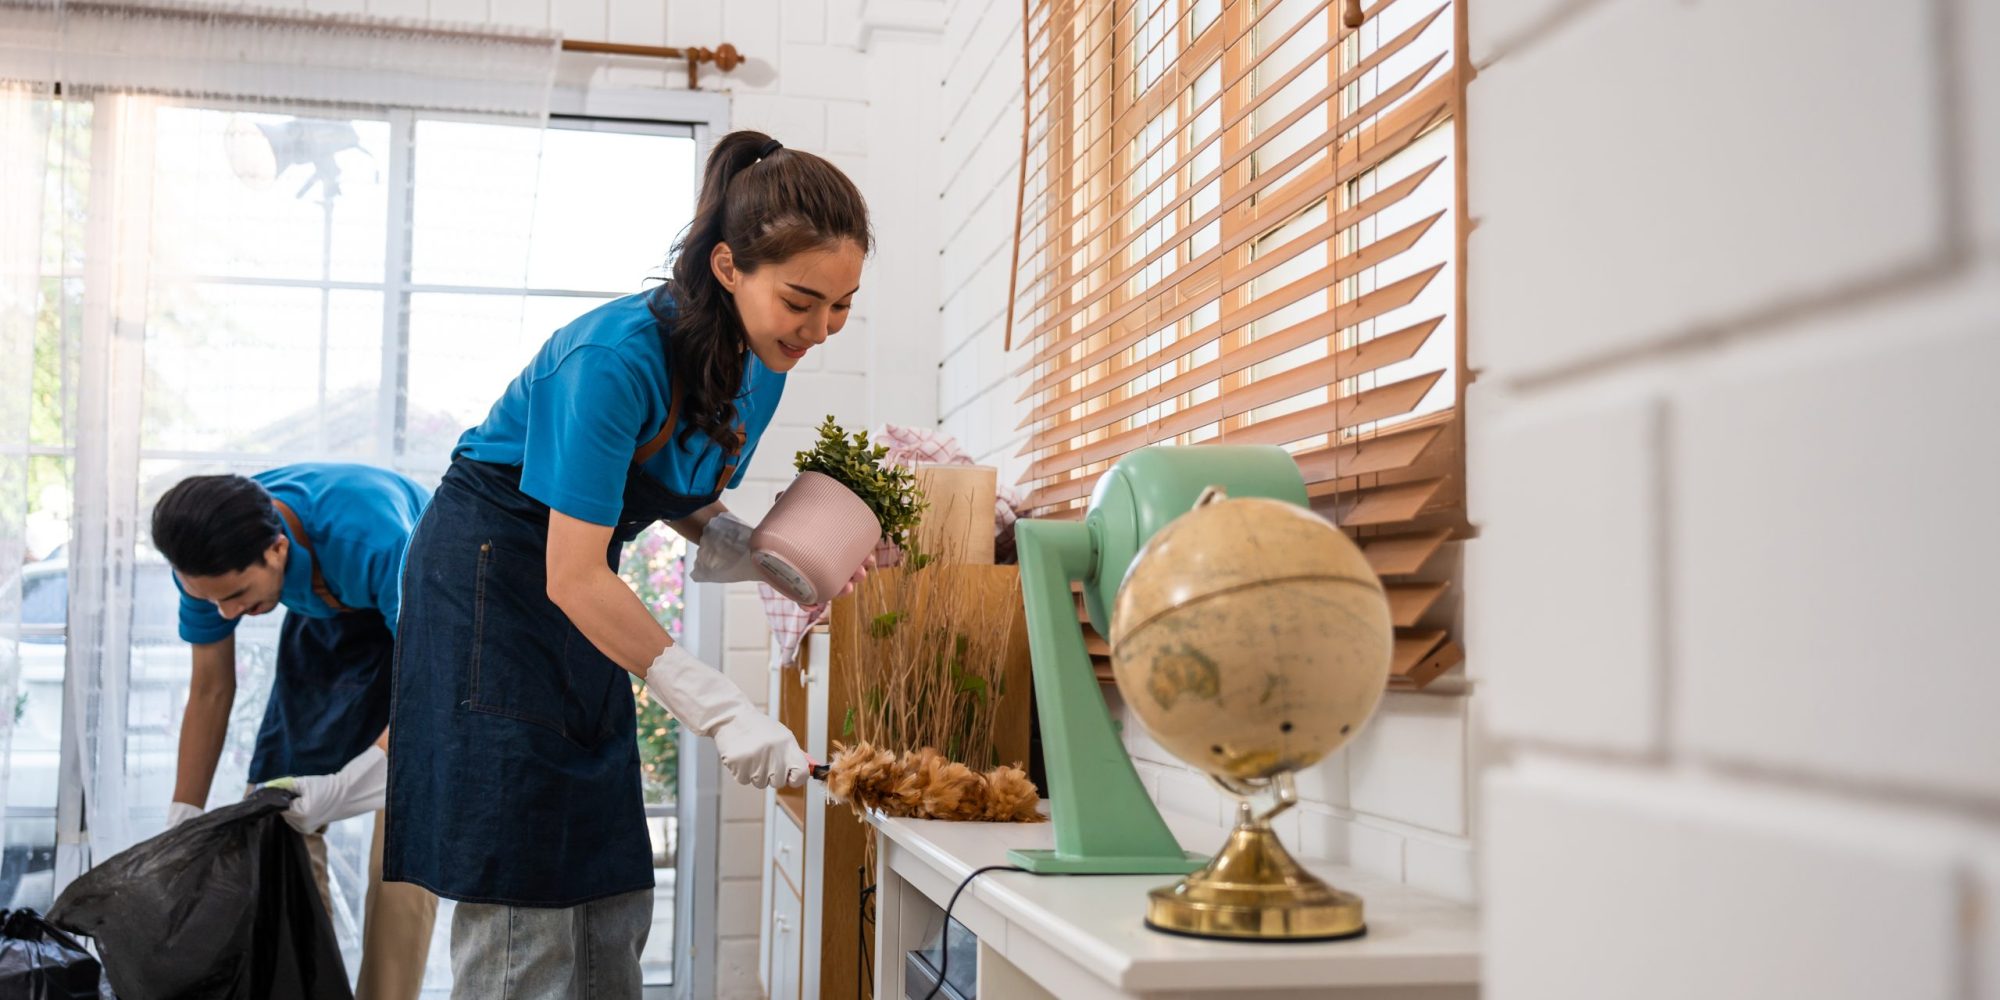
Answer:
[{"left": 248, "top": 502, "right": 396, "bottom": 784}]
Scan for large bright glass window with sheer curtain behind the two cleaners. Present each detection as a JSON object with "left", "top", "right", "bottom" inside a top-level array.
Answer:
[{"left": 17, "top": 94, "right": 698, "bottom": 988}]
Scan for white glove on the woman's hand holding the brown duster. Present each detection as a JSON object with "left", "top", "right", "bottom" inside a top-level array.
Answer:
[{"left": 646, "top": 646, "right": 806, "bottom": 788}]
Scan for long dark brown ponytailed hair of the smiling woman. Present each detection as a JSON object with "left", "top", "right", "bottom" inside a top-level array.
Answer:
[{"left": 654, "top": 132, "right": 874, "bottom": 448}]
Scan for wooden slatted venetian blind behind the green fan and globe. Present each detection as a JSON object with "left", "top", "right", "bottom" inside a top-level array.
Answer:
[{"left": 1006, "top": 0, "right": 1468, "bottom": 688}]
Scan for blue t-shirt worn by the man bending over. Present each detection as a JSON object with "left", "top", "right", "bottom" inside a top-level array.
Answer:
[{"left": 174, "top": 462, "right": 430, "bottom": 644}]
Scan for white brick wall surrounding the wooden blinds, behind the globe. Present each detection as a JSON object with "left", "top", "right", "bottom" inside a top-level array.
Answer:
[{"left": 928, "top": 0, "right": 1474, "bottom": 900}]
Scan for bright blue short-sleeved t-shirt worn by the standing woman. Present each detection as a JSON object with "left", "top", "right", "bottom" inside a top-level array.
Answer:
[{"left": 452, "top": 292, "right": 784, "bottom": 524}]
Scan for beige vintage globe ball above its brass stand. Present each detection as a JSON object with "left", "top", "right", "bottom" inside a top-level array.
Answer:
[{"left": 1110, "top": 498, "right": 1394, "bottom": 784}]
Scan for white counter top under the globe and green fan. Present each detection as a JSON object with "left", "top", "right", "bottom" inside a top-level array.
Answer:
[{"left": 872, "top": 816, "right": 1480, "bottom": 996}]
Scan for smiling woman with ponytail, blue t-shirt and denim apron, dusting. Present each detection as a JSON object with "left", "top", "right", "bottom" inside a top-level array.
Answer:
[{"left": 384, "top": 132, "right": 870, "bottom": 1000}]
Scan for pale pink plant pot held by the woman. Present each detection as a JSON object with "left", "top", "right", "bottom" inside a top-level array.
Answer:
[{"left": 750, "top": 472, "right": 882, "bottom": 604}]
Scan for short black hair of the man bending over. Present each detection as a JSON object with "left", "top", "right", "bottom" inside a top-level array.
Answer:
[{"left": 152, "top": 476, "right": 284, "bottom": 576}]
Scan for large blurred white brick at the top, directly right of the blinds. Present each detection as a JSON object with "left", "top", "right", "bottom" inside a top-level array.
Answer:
[{"left": 1466, "top": 0, "right": 1948, "bottom": 378}]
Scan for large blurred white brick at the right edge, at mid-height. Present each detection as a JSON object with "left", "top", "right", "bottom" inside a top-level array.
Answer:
[{"left": 1674, "top": 290, "right": 2000, "bottom": 802}]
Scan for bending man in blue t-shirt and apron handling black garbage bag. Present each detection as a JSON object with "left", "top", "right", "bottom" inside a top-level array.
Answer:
[{"left": 152, "top": 464, "right": 438, "bottom": 1000}]
